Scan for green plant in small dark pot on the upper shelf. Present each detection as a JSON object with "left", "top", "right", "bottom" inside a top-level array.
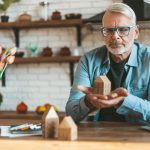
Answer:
[{"left": 0, "top": 0, "right": 20, "bottom": 22}]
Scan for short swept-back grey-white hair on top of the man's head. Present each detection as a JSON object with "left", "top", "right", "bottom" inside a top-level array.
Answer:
[{"left": 103, "top": 3, "right": 136, "bottom": 25}]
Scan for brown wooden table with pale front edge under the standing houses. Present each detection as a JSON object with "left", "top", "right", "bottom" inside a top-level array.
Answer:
[{"left": 0, "top": 119, "right": 150, "bottom": 150}]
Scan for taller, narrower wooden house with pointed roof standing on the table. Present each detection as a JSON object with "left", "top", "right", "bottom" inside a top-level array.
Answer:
[{"left": 42, "top": 106, "right": 59, "bottom": 138}]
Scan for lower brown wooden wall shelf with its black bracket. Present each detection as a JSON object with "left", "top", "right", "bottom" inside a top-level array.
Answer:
[{"left": 12, "top": 56, "right": 81, "bottom": 85}]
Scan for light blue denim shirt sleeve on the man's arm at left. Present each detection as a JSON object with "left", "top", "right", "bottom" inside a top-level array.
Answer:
[{"left": 66, "top": 56, "right": 91, "bottom": 122}]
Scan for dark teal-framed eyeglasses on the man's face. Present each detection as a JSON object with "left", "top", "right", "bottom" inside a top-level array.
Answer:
[{"left": 101, "top": 26, "right": 135, "bottom": 37}]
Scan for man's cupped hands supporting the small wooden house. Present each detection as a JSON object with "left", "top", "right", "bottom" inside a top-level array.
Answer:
[{"left": 77, "top": 85, "right": 128, "bottom": 109}]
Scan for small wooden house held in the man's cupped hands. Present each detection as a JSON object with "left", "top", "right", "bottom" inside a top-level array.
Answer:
[{"left": 93, "top": 76, "right": 111, "bottom": 95}]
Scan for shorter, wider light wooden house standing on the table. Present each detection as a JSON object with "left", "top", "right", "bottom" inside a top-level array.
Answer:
[{"left": 58, "top": 116, "right": 78, "bottom": 140}]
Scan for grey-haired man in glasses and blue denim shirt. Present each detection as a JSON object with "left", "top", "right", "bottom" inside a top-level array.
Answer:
[{"left": 66, "top": 3, "right": 150, "bottom": 123}]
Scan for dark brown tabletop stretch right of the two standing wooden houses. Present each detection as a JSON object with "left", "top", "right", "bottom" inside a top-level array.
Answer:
[{"left": 79, "top": 122, "right": 150, "bottom": 143}]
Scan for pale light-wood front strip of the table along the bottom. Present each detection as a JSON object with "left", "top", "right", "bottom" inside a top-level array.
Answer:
[{"left": 0, "top": 139, "right": 150, "bottom": 150}]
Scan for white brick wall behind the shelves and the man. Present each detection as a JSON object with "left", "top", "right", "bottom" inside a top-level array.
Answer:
[{"left": 0, "top": 0, "right": 149, "bottom": 111}]
